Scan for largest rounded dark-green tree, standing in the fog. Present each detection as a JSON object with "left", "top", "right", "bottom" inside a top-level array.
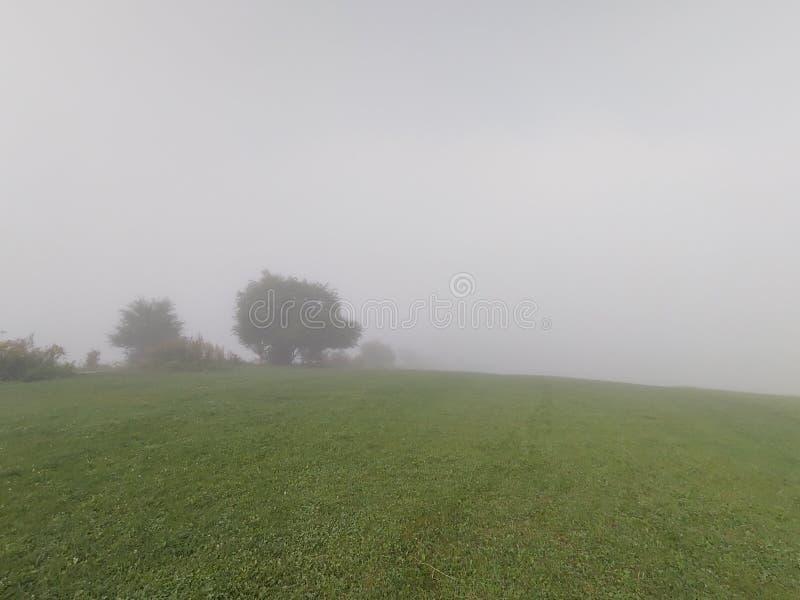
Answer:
[{"left": 233, "top": 271, "right": 361, "bottom": 365}]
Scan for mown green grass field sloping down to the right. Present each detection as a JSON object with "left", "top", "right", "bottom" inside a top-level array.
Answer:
[{"left": 0, "top": 368, "right": 800, "bottom": 599}]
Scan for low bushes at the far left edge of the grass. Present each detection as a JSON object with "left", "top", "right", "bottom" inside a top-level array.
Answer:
[{"left": 0, "top": 336, "right": 75, "bottom": 381}]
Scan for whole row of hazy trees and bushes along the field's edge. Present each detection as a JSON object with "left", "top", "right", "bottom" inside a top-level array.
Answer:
[{"left": 0, "top": 271, "right": 395, "bottom": 380}]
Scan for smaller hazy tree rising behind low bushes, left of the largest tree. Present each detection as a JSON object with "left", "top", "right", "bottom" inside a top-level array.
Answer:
[{"left": 109, "top": 298, "right": 183, "bottom": 361}]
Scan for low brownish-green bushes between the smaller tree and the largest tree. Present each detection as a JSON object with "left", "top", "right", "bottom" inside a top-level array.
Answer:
[{"left": 136, "top": 336, "right": 243, "bottom": 371}]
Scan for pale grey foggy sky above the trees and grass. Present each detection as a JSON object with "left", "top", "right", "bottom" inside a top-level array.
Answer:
[{"left": 0, "top": 0, "right": 800, "bottom": 393}]
